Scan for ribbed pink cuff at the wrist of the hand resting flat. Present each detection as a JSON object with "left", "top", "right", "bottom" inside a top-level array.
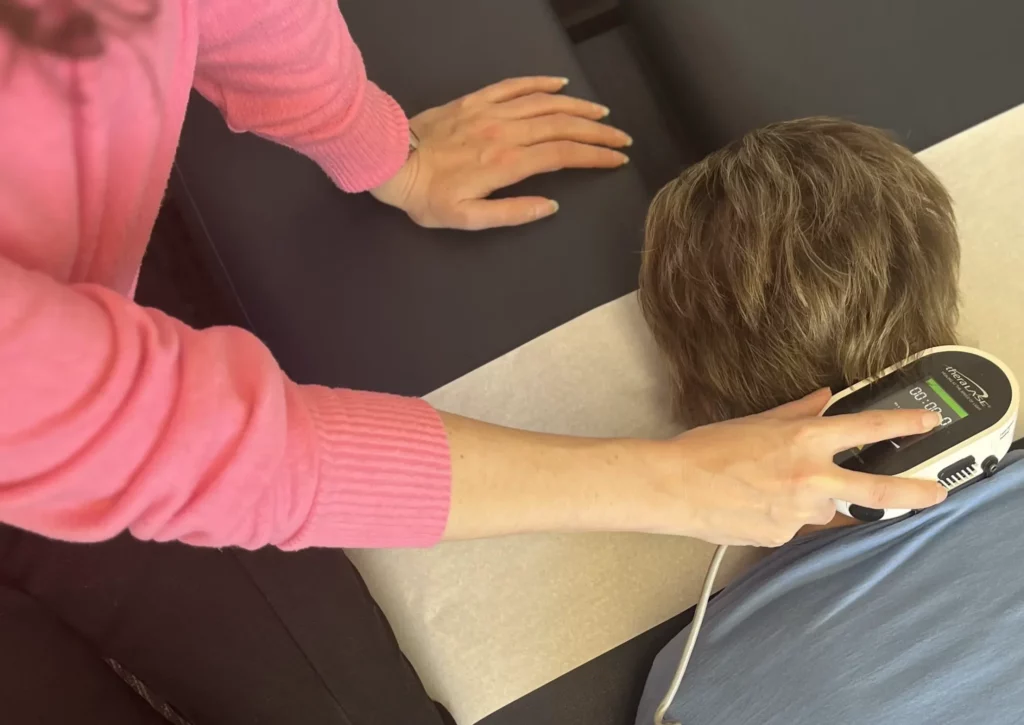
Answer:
[{"left": 299, "top": 81, "right": 409, "bottom": 191}]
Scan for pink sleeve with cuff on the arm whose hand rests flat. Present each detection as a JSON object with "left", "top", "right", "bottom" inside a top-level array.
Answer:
[{"left": 196, "top": 0, "right": 409, "bottom": 191}]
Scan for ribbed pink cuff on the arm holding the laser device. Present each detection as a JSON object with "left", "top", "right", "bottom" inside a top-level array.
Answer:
[{"left": 283, "top": 386, "right": 452, "bottom": 549}]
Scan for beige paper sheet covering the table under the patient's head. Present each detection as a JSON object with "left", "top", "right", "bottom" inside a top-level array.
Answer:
[{"left": 350, "top": 106, "right": 1024, "bottom": 725}]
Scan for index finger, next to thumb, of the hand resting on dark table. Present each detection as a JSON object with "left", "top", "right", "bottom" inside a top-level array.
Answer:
[{"left": 479, "top": 141, "right": 630, "bottom": 194}]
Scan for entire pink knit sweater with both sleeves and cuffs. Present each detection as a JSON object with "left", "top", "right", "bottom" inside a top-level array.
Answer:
[{"left": 0, "top": 0, "right": 451, "bottom": 548}]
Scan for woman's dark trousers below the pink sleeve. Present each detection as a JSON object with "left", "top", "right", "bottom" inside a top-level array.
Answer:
[{"left": 0, "top": 527, "right": 442, "bottom": 725}]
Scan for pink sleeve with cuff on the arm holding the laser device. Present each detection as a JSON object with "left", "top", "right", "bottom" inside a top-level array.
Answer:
[{"left": 0, "top": 256, "right": 451, "bottom": 548}]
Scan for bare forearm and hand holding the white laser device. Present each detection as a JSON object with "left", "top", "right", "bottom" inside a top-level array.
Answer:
[{"left": 443, "top": 390, "right": 945, "bottom": 547}]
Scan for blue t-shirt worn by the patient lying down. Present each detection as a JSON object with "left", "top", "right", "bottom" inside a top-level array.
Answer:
[{"left": 637, "top": 453, "right": 1024, "bottom": 725}]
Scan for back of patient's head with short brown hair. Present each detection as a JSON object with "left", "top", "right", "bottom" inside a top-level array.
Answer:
[{"left": 640, "top": 118, "right": 959, "bottom": 425}]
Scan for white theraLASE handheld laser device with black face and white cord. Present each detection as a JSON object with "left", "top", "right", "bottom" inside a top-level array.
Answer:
[{"left": 654, "top": 345, "right": 1020, "bottom": 725}]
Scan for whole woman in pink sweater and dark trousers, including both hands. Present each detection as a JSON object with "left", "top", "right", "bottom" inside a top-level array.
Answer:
[{"left": 0, "top": 0, "right": 958, "bottom": 725}]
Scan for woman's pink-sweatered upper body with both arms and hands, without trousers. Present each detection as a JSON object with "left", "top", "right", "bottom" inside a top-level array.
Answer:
[{"left": 0, "top": 0, "right": 941, "bottom": 548}]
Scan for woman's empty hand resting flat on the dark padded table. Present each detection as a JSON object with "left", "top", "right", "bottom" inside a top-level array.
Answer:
[{"left": 372, "top": 77, "right": 632, "bottom": 229}]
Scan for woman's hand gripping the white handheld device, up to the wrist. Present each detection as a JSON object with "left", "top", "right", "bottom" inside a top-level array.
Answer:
[{"left": 651, "top": 390, "right": 946, "bottom": 547}]
